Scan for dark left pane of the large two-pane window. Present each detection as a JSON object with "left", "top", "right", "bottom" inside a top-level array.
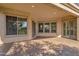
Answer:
[{"left": 6, "top": 16, "right": 17, "bottom": 35}]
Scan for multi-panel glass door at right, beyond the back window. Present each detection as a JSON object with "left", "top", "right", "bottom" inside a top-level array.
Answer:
[{"left": 63, "top": 20, "right": 77, "bottom": 39}]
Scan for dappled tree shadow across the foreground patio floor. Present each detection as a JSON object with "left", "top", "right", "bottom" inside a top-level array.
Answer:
[{"left": 7, "top": 41, "right": 79, "bottom": 56}]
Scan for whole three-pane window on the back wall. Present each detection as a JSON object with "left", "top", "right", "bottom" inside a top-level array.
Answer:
[{"left": 38, "top": 22, "right": 56, "bottom": 33}]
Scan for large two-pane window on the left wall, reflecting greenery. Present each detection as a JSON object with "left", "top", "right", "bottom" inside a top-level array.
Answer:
[{"left": 6, "top": 16, "right": 27, "bottom": 35}]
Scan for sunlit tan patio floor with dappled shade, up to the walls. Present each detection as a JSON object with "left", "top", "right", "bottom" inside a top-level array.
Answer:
[{"left": 6, "top": 38, "right": 79, "bottom": 56}]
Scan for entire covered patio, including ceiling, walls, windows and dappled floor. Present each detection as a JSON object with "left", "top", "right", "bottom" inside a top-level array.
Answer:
[{"left": 0, "top": 3, "right": 79, "bottom": 56}]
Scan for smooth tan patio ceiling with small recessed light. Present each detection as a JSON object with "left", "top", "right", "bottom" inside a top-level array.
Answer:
[{"left": 0, "top": 3, "right": 75, "bottom": 19}]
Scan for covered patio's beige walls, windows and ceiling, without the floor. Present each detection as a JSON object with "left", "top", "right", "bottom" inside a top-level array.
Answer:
[{"left": 0, "top": 3, "right": 79, "bottom": 44}]
